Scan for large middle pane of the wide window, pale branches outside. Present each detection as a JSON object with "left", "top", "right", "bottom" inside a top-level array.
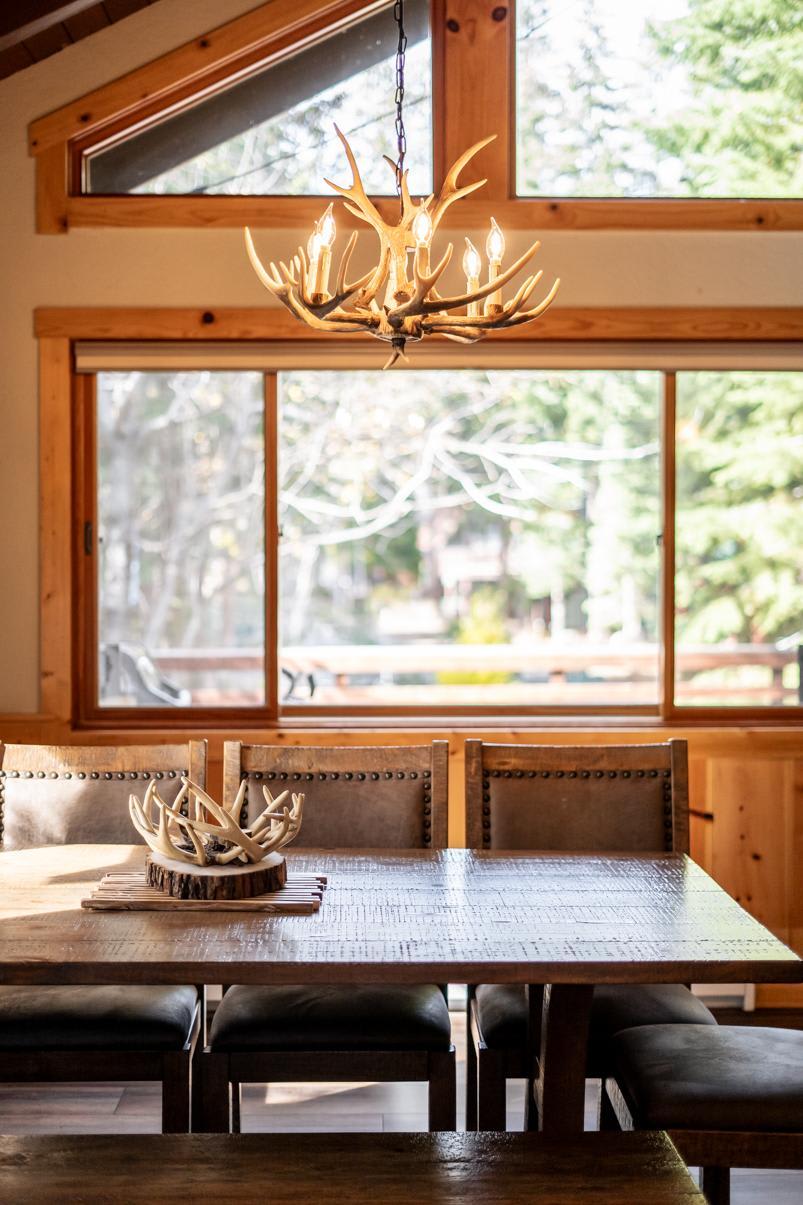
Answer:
[{"left": 279, "top": 371, "right": 661, "bottom": 709}]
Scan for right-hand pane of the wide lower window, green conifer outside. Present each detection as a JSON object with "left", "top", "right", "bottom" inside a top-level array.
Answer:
[{"left": 675, "top": 372, "right": 803, "bottom": 707}]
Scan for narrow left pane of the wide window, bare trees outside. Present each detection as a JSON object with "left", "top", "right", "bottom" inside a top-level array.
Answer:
[{"left": 94, "top": 372, "right": 266, "bottom": 707}]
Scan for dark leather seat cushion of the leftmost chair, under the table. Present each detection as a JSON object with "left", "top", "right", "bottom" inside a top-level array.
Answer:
[{"left": 0, "top": 984, "right": 198, "bottom": 1051}]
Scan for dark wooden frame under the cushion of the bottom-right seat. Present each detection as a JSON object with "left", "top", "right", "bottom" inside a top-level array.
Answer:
[{"left": 600, "top": 1077, "right": 803, "bottom": 1205}]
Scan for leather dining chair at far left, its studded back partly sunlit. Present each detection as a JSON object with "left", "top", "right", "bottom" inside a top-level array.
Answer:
[{"left": 0, "top": 741, "right": 206, "bottom": 1134}]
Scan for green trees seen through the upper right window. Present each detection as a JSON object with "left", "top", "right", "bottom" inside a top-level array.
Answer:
[{"left": 516, "top": 0, "right": 803, "bottom": 198}]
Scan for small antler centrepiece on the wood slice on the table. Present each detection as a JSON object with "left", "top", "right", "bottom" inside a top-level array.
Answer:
[{"left": 128, "top": 777, "right": 304, "bottom": 866}]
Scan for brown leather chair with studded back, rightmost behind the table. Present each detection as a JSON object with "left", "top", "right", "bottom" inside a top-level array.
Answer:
[{"left": 465, "top": 740, "right": 716, "bottom": 1130}]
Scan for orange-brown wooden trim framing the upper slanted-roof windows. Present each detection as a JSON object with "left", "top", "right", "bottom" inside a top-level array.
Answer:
[{"left": 29, "top": 0, "right": 803, "bottom": 234}]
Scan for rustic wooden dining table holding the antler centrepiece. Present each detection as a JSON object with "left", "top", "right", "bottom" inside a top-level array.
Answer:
[{"left": 0, "top": 845, "right": 803, "bottom": 1136}]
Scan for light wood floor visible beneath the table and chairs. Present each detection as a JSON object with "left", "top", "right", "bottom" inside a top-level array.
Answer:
[{"left": 0, "top": 1012, "right": 803, "bottom": 1205}]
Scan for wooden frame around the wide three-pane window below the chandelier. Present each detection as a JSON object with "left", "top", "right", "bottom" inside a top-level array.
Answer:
[{"left": 35, "top": 308, "right": 803, "bottom": 729}]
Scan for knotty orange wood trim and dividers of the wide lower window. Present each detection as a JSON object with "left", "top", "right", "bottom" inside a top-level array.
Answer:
[{"left": 35, "top": 307, "right": 803, "bottom": 730}]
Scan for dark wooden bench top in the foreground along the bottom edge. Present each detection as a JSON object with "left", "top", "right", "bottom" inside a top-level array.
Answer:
[{"left": 0, "top": 1133, "right": 704, "bottom": 1205}]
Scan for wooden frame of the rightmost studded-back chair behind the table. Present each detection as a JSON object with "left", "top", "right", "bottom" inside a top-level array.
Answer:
[{"left": 465, "top": 740, "right": 688, "bottom": 1130}]
